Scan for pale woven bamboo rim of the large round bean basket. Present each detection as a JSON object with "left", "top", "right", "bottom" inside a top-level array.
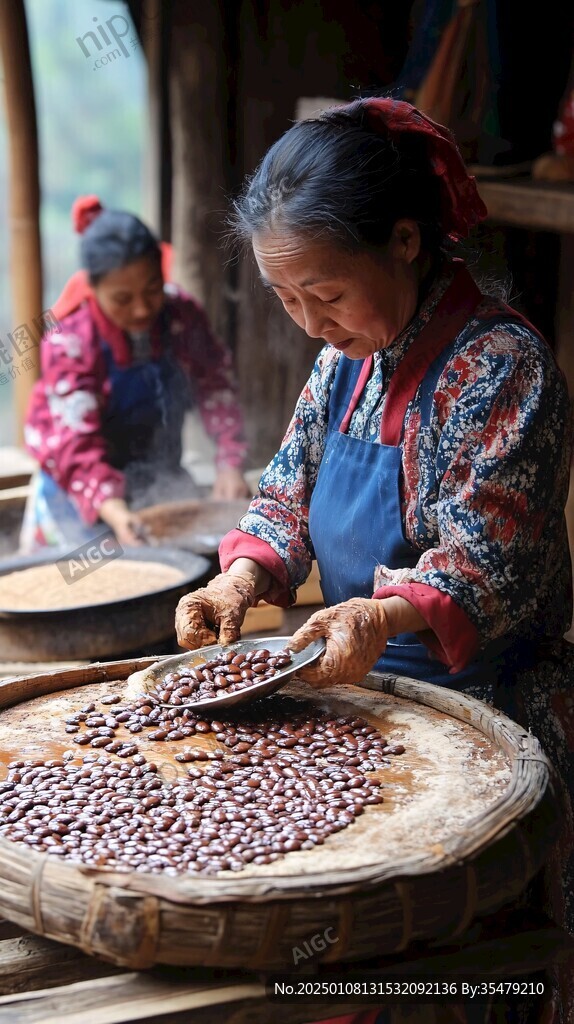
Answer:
[{"left": 0, "top": 657, "right": 556, "bottom": 905}]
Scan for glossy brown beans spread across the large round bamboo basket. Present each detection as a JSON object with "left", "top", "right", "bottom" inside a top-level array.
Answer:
[{"left": 0, "top": 695, "right": 404, "bottom": 874}]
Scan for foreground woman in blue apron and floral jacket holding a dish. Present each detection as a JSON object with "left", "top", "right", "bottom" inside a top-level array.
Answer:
[{"left": 176, "top": 98, "right": 574, "bottom": 1019}]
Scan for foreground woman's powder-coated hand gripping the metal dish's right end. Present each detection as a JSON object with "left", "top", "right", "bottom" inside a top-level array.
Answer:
[{"left": 289, "top": 597, "right": 389, "bottom": 686}]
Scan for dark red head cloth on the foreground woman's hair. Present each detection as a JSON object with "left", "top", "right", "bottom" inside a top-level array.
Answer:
[{"left": 361, "top": 97, "right": 488, "bottom": 241}]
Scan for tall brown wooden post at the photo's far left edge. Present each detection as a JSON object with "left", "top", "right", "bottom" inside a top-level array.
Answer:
[{"left": 0, "top": 0, "right": 42, "bottom": 441}]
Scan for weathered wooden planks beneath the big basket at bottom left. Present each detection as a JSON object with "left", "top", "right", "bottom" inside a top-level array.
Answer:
[{"left": 0, "top": 921, "right": 361, "bottom": 1024}]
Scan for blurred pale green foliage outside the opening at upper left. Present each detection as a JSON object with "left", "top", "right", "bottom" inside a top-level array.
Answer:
[{"left": 0, "top": 0, "right": 146, "bottom": 444}]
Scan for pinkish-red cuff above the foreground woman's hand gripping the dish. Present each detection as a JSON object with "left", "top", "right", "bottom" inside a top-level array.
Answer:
[{"left": 372, "top": 583, "right": 479, "bottom": 673}]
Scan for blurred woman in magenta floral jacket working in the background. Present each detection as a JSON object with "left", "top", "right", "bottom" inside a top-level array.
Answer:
[{"left": 21, "top": 197, "right": 249, "bottom": 552}]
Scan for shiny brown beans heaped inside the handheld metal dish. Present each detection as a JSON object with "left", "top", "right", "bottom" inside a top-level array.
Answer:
[{"left": 150, "top": 648, "right": 293, "bottom": 707}]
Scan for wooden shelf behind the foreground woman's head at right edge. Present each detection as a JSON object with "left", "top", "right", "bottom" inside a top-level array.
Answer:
[{"left": 477, "top": 178, "right": 574, "bottom": 234}]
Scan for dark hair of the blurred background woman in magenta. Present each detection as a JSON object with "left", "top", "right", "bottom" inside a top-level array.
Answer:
[{"left": 80, "top": 210, "right": 162, "bottom": 285}]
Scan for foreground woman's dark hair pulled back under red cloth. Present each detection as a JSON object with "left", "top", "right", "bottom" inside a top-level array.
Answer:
[{"left": 231, "top": 100, "right": 447, "bottom": 256}]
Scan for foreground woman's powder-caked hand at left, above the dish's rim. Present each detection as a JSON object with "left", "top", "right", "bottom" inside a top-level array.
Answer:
[{"left": 175, "top": 570, "right": 257, "bottom": 650}]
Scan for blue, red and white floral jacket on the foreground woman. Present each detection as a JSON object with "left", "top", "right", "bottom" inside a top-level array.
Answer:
[{"left": 220, "top": 264, "right": 571, "bottom": 671}]
